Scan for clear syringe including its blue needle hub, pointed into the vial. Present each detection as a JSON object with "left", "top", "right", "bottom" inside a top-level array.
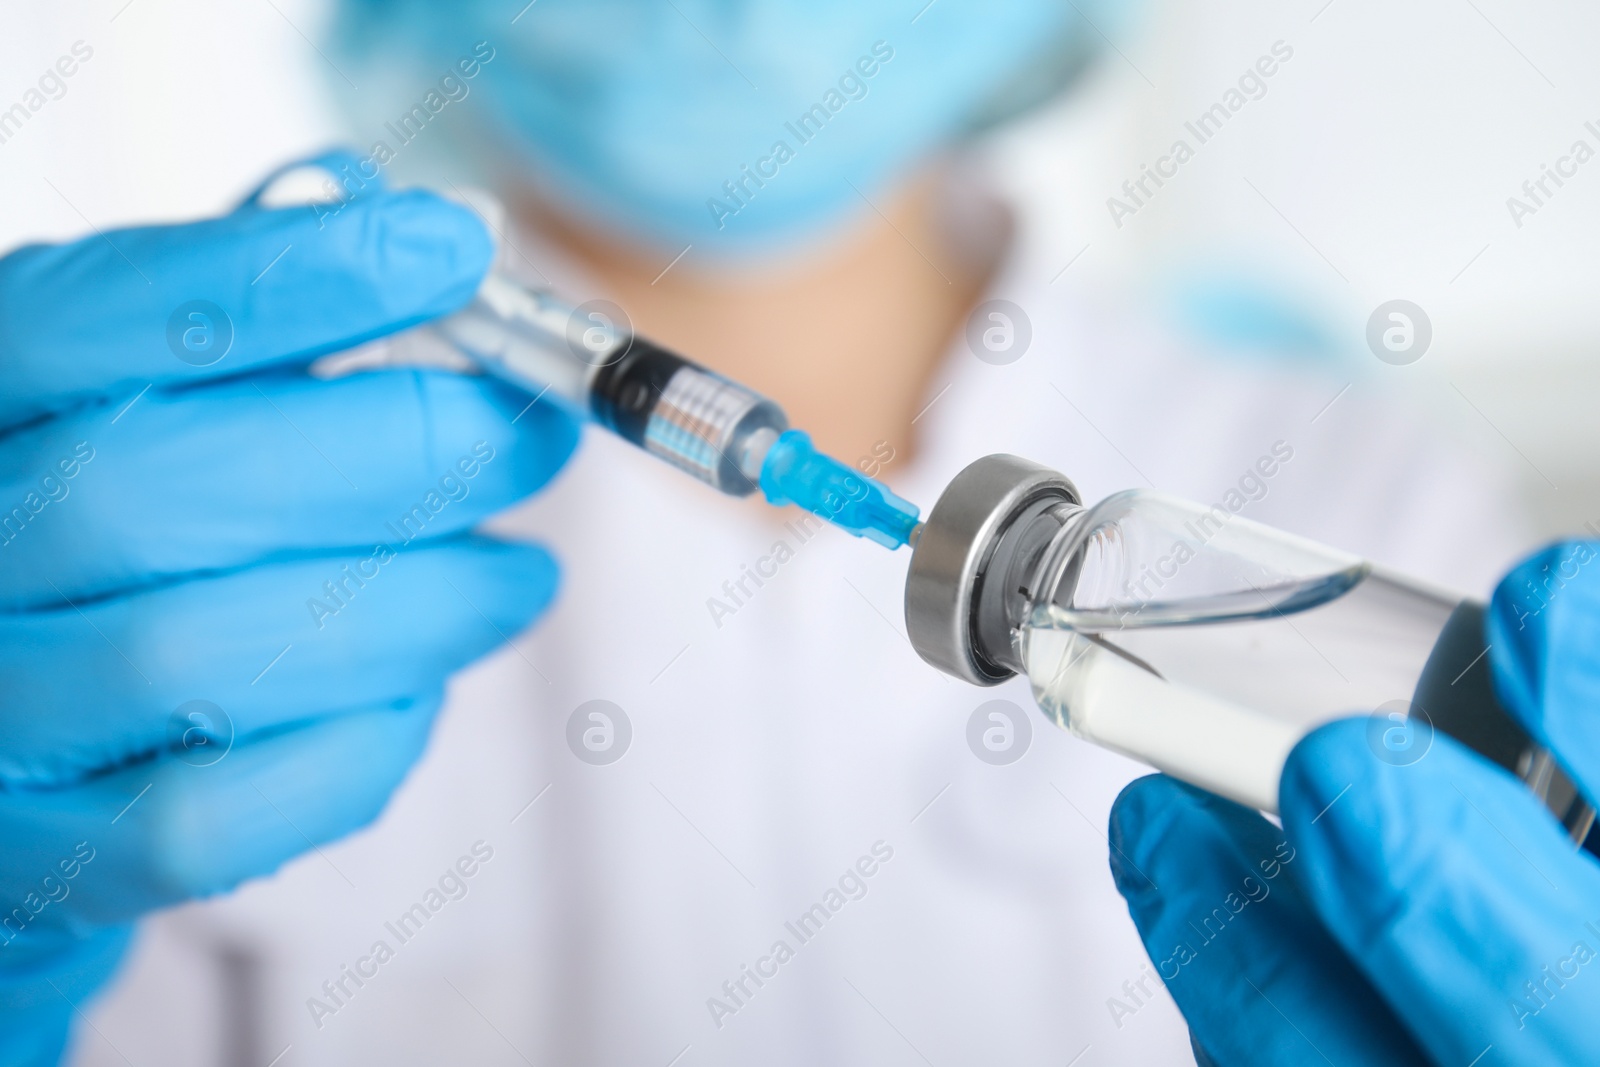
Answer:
[{"left": 427, "top": 270, "right": 917, "bottom": 549}]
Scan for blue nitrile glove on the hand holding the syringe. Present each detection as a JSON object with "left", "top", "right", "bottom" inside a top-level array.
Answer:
[{"left": 0, "top": 151, "right": 576, "bottom": 1064}]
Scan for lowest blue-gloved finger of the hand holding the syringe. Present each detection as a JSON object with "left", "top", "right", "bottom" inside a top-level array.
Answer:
[{"left": 0, "top": 693, "right": 440, "bottom": 927}]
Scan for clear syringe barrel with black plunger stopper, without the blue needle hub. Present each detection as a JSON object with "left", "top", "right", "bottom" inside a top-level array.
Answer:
[{"left": 430, "top": 272, "right": 789, "bottom": 496}]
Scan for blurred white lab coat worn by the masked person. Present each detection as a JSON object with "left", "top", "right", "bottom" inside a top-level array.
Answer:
[{"left": 77, "top": 171, "right": 1522, "bottom": 1067}]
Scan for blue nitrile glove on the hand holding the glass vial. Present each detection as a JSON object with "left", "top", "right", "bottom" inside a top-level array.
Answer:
[{"left": 1110, "top": 542, "right": 1600, "bottom": 1067}]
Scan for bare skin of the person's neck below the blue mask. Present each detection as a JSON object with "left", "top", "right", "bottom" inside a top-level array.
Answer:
[{"left": 523, "top": 184, "right": 992, "bottom": 466}]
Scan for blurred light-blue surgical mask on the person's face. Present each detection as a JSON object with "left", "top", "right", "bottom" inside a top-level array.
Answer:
[{"left": 338, "top": 0, "right": 1098, "bottom": 258}]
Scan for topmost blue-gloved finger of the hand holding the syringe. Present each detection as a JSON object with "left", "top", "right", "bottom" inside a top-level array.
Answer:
[{"left": 0, "top": 190, "right": 494, "bottom": 427}]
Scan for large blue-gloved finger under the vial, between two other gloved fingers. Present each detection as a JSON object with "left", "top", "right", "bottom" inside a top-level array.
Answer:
[{"left": 1280, "top": 718, "right": 1600, "bottom": 1064}]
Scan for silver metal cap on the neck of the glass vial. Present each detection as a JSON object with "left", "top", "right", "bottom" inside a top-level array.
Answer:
[{"left": 906, "top": 454, "right": 1080, "bottom": 685}]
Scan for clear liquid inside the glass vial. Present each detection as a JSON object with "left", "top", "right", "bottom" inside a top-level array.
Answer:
[{"left": 1018, "top": 563, "right": 1459, "bottom": 811}]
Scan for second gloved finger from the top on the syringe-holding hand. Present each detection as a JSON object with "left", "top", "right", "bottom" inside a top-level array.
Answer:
[{"left": 0, "top": 371, "right": 578, "bottom": 609}]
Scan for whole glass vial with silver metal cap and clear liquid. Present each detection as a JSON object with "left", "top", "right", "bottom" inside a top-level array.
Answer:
[{"left": 906, "top": 456, "right": 1594, "bottom": 840}]
